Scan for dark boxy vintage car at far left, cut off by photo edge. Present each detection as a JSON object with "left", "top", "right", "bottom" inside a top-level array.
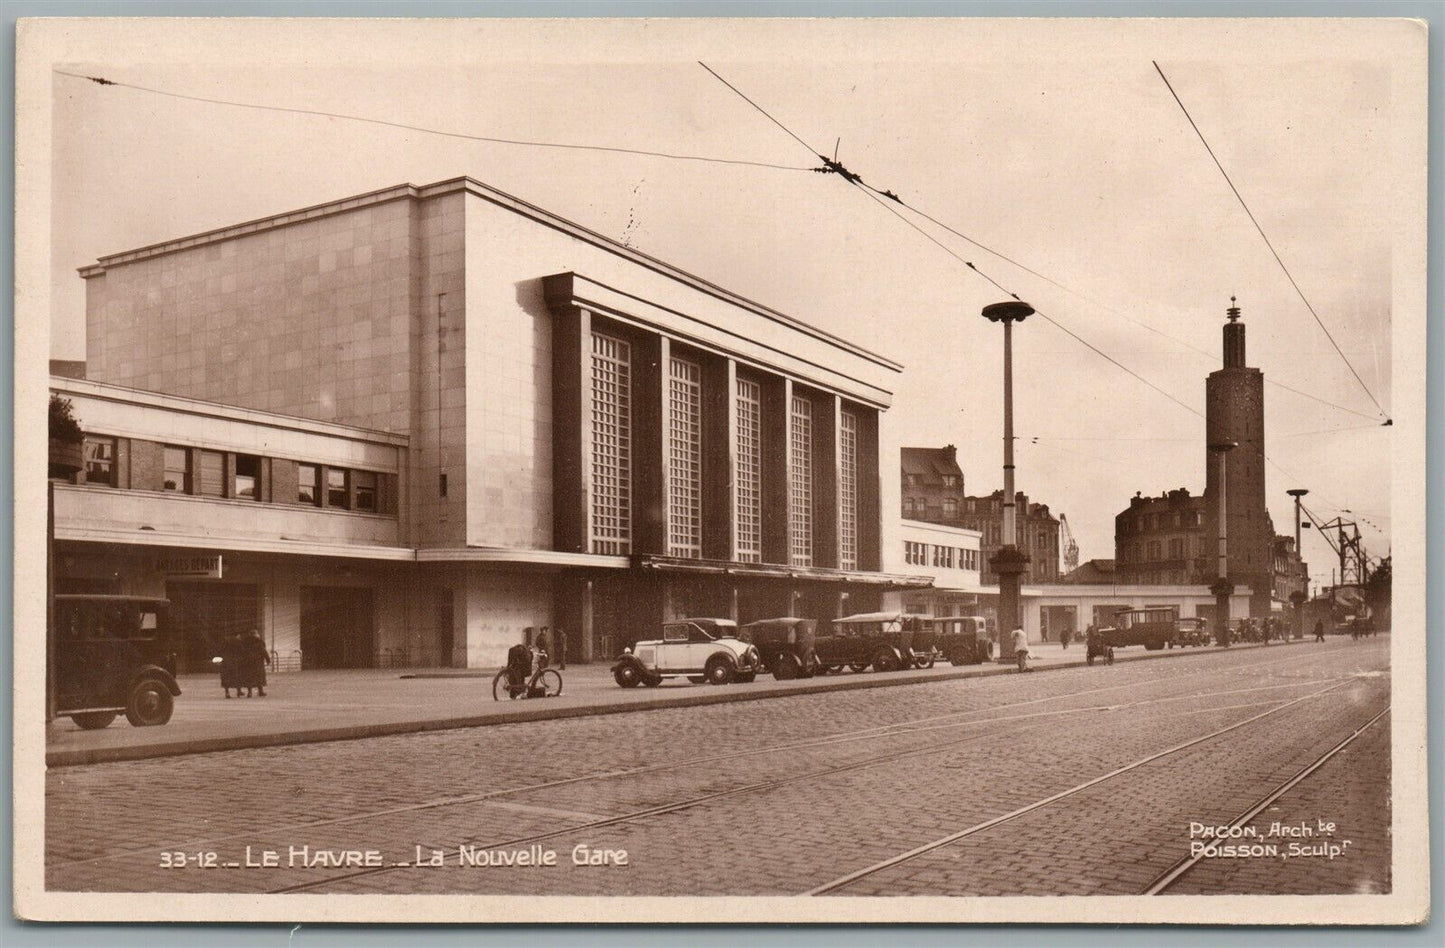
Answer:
[{"left": 55, "top": 594, "right": 181, "bottom": 730}]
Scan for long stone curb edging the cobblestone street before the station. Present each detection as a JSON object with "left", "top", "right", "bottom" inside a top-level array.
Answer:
[{"left": 45, "top": 640, "right": 1303, "bottom": 767}]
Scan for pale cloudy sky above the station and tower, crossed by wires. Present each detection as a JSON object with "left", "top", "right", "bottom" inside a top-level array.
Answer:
[{"left": 39, "top": 23, "right": 1416, "bottom": 582}]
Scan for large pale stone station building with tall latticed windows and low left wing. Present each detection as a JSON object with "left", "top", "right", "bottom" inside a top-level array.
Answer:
[{"left": 59, "top": 178, "right": 929, "bottom": 669}]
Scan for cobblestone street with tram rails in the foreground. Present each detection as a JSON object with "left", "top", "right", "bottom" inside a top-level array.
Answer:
[{"left": 46, "top": 637, "right": 1390, "bottom": 896}]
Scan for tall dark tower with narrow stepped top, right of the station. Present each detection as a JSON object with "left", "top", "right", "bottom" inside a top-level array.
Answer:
[{"left": 1204, "top": 296, "right": 1274, "bottom": 619}]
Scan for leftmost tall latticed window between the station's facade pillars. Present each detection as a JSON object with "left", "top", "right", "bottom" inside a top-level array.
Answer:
[{"left": 591, "top": 332, "right": 631, "bottom": 555}]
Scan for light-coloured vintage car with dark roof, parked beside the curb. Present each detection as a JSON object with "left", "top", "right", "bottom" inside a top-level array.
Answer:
[{"left": 613, "top": 619, "right": 763, "bottom": 688}]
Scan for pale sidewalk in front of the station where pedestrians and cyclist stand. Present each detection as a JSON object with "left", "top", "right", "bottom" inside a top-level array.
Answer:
[{"left": 45, "top": 632, "right": 1279, "bottom": 767}]
